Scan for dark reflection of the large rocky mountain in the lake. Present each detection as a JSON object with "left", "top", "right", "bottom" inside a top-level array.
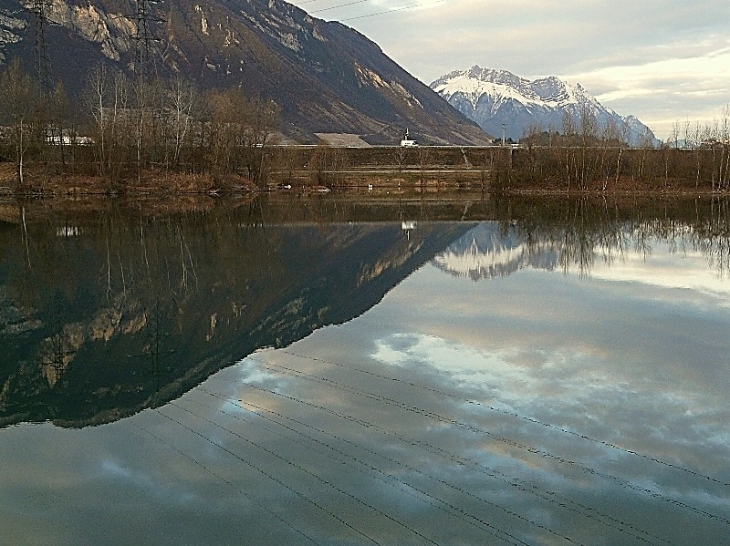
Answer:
[{"left": 0, "top": 198, "right": 469, "bottom": 427}]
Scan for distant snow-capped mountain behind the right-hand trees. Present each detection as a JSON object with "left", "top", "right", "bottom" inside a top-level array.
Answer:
[{"left": 431, "top": 66, "right": 656, "bottom": 145}]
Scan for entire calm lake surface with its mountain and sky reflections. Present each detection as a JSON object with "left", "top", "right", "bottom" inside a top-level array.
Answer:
[{"left": 0, "top": 198, "right": 730, "bottom": 545}]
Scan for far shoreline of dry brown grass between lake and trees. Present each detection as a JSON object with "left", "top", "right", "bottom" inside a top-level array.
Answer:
[{"left": 0, "top": 153, "right": 730, "bottom": 200}]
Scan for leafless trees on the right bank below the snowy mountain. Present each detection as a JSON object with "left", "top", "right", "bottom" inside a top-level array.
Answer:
[{"left": 495, "top": 108, "right": 730, "bottom": 192}]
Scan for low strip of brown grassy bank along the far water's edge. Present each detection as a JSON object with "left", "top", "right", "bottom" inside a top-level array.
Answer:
[{"left": 0, "top": 168, "right": 730, "bottom": 199}]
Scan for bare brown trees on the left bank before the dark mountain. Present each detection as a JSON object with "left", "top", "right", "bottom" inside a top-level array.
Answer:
[{"left": 0, "top": 60, "right": 279, "bottom": 184}]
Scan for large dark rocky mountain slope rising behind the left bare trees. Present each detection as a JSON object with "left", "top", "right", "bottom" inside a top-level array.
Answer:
[{"left": 0, "top": 0, "right": 486, "bottom": 144}]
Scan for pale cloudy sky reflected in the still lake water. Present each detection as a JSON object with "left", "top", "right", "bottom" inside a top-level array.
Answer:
[{"left": 0, "top": 221, "right": 730, "bottom": 545}]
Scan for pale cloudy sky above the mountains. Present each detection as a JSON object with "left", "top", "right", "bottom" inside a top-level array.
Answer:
[{"left": 292, "top": 0, "right": 730, "bottom": 138}]
